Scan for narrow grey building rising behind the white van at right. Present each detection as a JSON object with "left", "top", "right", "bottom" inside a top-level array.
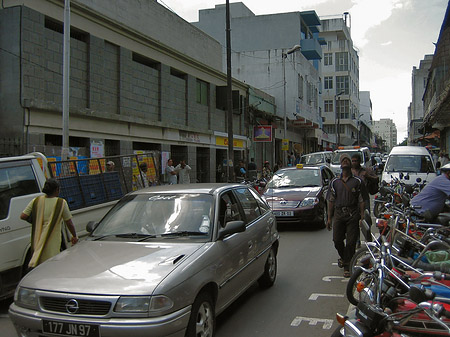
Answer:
[{"left": 408, "top": 55, "right": 433, "bottom": 145}]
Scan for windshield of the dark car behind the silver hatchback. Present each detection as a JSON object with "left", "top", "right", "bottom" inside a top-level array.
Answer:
[{"left": 267, "top": 169, "right": 320, "bottom": 188}]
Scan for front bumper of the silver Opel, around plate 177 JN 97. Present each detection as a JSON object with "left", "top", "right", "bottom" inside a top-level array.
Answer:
[{"left": 9, "top": 303, "right": 191, "bottom": 337}]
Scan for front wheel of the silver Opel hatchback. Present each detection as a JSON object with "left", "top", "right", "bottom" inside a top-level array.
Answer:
[{"left": 186, "top": 292, "right": 216, "bottom": 337}]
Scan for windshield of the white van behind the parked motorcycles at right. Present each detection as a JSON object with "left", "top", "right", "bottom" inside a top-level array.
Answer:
[{"left": 386, "top": 155, "right": 434, "bottom": 173}]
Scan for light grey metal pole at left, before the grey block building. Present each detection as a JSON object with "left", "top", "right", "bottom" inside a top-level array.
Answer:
[{"left": 61, "top": 0, "right": 70, "bottom": 160}]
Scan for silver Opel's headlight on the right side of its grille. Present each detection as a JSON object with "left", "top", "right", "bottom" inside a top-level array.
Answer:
[{"left": 114, "top": 296, "right": 173, "bottom": 313}]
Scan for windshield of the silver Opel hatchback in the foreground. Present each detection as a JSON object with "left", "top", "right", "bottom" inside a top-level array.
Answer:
[{"left": 92, "top": 194, "right": 214, "bottom": 239}]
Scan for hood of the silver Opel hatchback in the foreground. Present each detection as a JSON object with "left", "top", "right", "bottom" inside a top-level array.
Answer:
[{"left": 21, "top": 241, "right": 205, "bottom": 295}]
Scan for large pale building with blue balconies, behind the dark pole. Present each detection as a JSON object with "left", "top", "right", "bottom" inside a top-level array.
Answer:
[{"left": 193, "top": 2, "right": 329, "bottom": 160}]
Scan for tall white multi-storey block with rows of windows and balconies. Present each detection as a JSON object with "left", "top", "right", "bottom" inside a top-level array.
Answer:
[{"left": 319, "top": 13, "right": 359, "bottom": 145}]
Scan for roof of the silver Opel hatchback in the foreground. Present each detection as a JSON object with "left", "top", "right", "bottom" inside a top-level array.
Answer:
[{"left": 131, "top": 183, "right": 246, "bottom": 194}]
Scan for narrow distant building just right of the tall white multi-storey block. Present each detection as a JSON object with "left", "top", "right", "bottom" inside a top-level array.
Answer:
[{"left": 357, "top": 91, "right": 376, "bottom": 148}]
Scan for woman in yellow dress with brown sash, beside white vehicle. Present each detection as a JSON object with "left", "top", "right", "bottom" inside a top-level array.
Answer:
[{"left": 20, "top": 178, "right": 78, "bottom": 268}]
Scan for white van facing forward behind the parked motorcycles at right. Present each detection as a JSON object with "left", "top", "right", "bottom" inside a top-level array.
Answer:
[{"left": 382, "top": 146, "right": 436, "bottom": 184}]
